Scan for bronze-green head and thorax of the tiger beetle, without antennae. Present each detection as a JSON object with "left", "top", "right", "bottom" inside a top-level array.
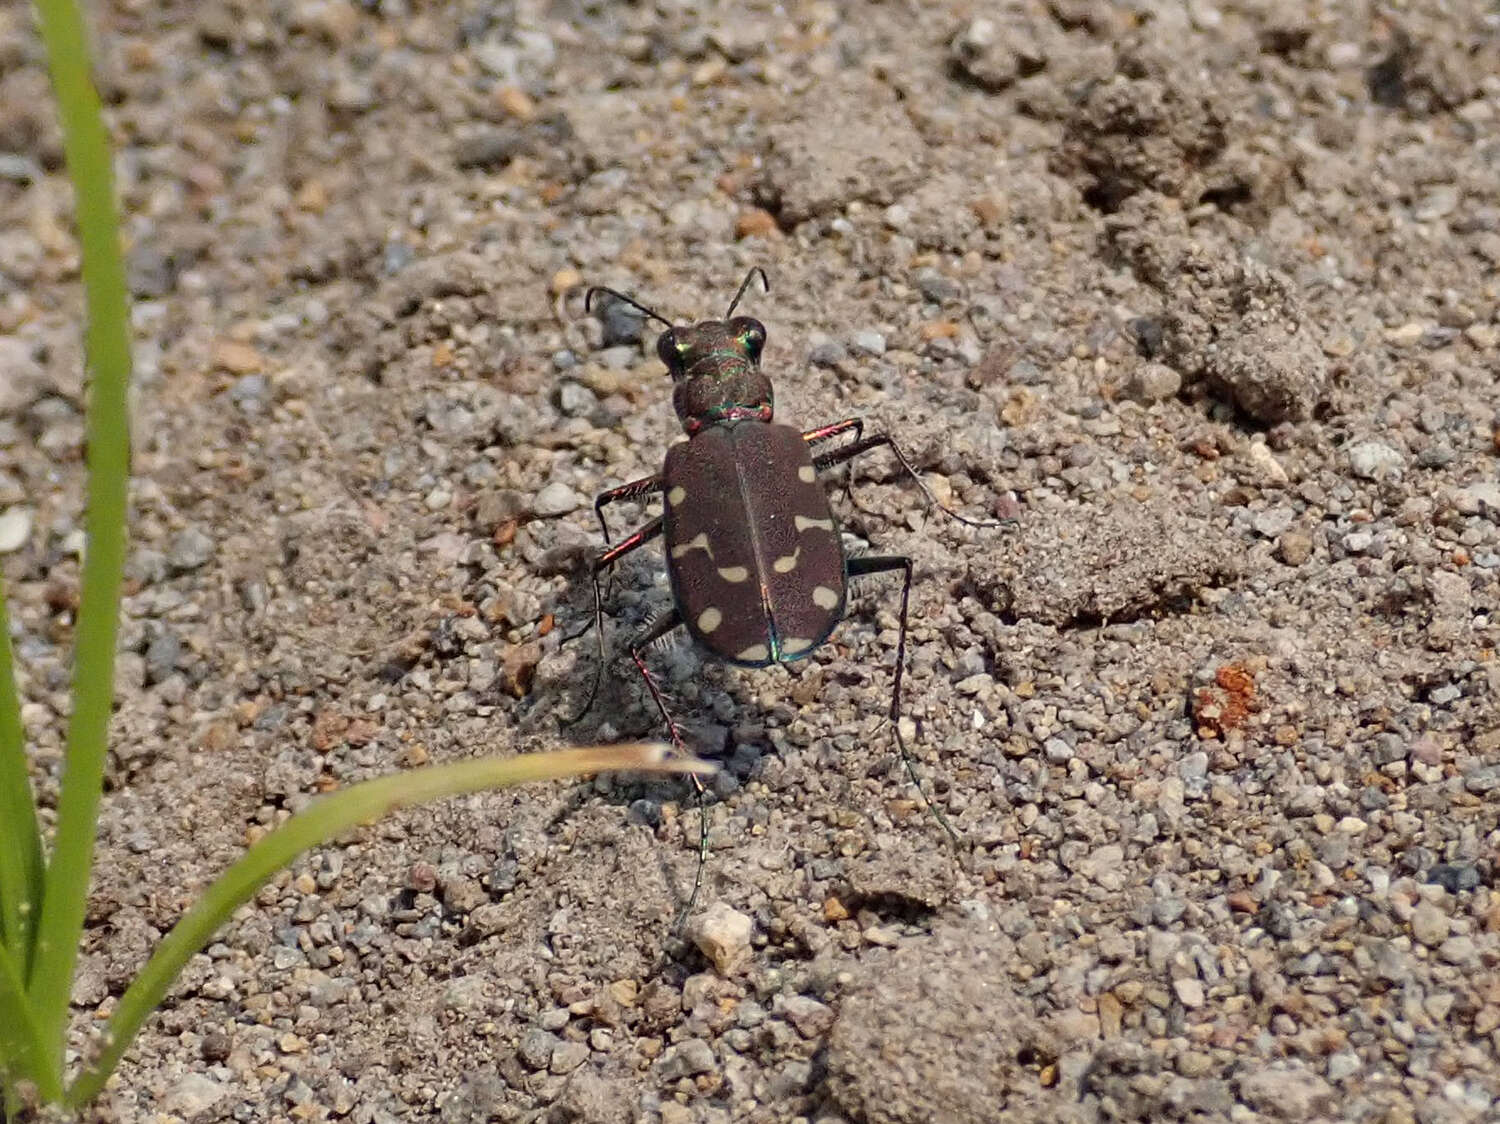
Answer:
[{"left": 657, "top": 317, "right": 773, "bottom": 435}]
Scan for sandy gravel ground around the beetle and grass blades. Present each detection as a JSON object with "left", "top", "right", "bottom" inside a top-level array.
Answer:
[{"left": 0, "top": 0, "right": 1500, "bottom": 1124}]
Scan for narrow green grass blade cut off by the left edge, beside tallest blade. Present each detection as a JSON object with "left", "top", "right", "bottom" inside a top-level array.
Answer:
[{"left": 0, "top": 582, "right": 42, "bottom": 978}]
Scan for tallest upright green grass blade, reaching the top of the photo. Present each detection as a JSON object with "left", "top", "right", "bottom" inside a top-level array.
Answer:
[{"left": 27, "top": 0, "right": 131, "bottom": 1064}]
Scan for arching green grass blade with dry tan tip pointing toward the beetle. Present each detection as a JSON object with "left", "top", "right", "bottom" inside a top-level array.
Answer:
[{"left": 66, "top": 746, "right": 713, "bottom": 1109}]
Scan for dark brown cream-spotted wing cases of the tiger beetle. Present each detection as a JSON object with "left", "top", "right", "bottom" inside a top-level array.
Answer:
[{"left": 662, "top": 420, "right": 845, "bottom": 668}]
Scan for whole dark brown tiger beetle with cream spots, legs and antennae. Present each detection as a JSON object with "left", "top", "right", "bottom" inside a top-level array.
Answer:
[{"left": 572, "top": 266, "right": 1002, "bottom": 917}]
